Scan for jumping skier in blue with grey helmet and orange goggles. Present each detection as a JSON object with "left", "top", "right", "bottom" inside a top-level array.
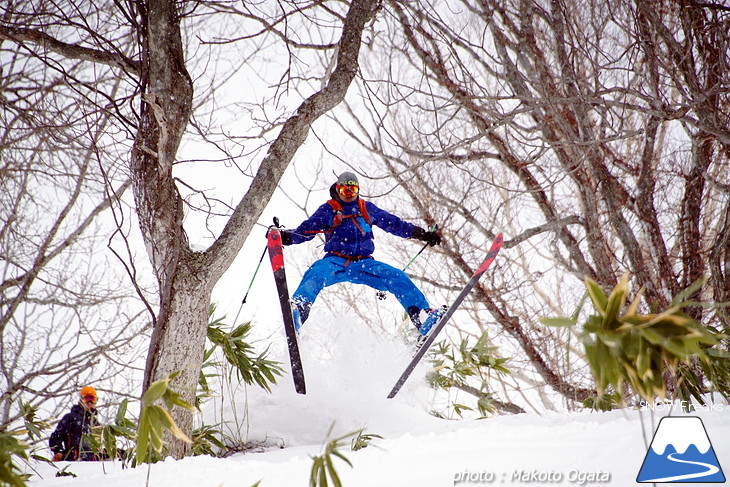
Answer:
[{"left": 281, "top": 171, "right": 442, "bottom": 335}]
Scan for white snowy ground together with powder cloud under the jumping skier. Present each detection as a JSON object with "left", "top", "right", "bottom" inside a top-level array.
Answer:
[{"left": 24, "top": 314, "right": 730, "bottom": 487}]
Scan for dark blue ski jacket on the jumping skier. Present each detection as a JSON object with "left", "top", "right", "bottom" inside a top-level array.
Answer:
[{"left": 290, "top": 198, "right": 416, "bottom": 257}]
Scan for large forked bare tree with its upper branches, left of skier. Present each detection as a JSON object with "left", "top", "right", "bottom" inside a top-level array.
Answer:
[{"left": 0, "top": 0, "right": 378, "bottom": 457}]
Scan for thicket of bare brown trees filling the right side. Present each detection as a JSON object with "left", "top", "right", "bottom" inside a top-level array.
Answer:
[{"left": 322, "top": 0, "right": 730, "bottom": 412}]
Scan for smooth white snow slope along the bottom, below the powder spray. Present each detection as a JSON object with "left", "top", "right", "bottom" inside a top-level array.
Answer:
[{"left": 22, "top": 406, "right": 730, "bottom": 487}]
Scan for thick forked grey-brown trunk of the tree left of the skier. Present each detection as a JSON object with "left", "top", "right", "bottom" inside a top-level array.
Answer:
[{"left": 131, "top": 0, "right": 378, "bottom": 458}]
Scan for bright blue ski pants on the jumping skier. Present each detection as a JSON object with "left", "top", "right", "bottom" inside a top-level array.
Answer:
[{"left": 292, "top": 255, "right": 429, "bottom": 328}]
